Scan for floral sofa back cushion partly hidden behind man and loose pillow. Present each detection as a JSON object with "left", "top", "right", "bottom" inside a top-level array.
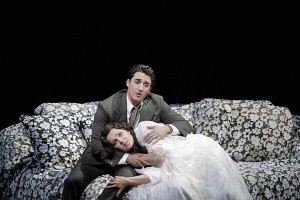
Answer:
[{"left": 34, "top": 102, "right": 97, "bottom": 142}]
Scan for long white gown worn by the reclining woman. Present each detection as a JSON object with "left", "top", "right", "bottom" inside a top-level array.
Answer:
[{"left": 128, "top": 121, "right": 252, "bottom": 200}]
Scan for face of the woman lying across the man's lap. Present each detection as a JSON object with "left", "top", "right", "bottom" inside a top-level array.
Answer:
[{"left": 106, "top": 128, "right": 134, "bottom": 152}]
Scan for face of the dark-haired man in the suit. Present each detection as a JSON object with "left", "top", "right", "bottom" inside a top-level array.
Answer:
[{"left": 126, "top": 72, "right": 152, "bottom": 106}]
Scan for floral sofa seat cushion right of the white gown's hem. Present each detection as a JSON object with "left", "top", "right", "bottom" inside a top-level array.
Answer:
[{"left": 237, "top": 158, "right": 300, "bottom": 200}]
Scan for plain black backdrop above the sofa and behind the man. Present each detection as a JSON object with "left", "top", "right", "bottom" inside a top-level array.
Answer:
[{"left": 0, "top": 0, "right": 300, "bottom": 129}]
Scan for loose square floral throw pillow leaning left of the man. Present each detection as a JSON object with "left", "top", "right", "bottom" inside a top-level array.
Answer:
[{"left": 20, "top": 113, "right": 86, "bottom": 169}]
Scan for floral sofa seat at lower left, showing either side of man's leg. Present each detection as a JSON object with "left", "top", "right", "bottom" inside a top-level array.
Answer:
[{"left": 4, "top": 166, "right": 113, "bottom": 200}]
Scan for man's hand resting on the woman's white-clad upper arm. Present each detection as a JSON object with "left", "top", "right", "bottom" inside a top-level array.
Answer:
[{"left": 144, "top": 125, "right": 173, "bottom": 144}]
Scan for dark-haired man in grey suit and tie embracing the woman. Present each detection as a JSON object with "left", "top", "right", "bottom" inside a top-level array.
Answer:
[{"left": 62, "top": 64, "right": 192, "bottom": 200}]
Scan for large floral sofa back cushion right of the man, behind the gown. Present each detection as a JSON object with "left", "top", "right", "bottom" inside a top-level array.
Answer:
[{"left": 193, "top": 99, "right": 295, "bottom": 161}]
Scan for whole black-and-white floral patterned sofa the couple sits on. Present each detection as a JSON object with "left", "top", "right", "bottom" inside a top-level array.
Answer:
[{"left": 0, "top": 99, "right": 300, "bottom": 200}]
